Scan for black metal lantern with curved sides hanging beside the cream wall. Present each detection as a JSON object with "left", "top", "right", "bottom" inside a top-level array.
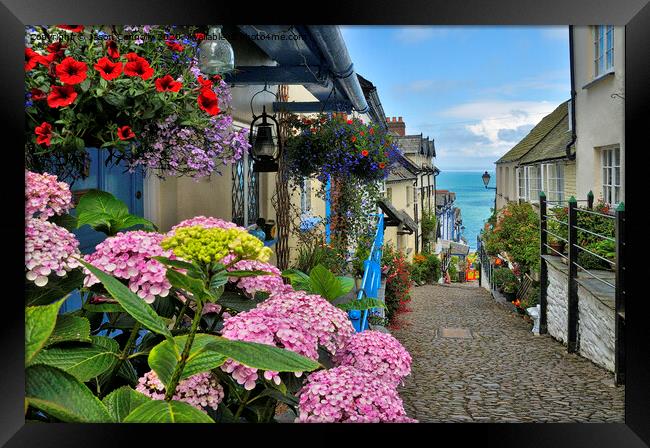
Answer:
[{"left": 249, "top": 106, "right": 282, "bottom": 173}]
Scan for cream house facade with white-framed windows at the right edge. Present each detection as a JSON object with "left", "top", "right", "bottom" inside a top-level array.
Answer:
[{"left": 571, "top": 25, "right": 625, "bottom": 205}]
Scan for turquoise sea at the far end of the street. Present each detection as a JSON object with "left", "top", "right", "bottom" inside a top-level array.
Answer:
[{"left": 436, "top": 168, "right": 496, "bottom": 250}]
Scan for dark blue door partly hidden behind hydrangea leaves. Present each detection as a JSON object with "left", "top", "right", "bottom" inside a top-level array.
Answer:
[{"left": 61, "top": 148, "right": 144, "bottom": 313}]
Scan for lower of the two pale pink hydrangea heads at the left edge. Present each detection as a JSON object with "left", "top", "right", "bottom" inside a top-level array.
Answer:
[{"left": 25, "top": 218, "right": 80, "bottom": 286}]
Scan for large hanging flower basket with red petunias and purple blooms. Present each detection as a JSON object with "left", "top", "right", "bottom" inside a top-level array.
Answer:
[{"left": 25, "top": 25, "right": 248, "bottom": 179}]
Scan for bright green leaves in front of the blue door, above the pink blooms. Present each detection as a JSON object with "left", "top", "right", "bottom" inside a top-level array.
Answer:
[{"left": 75, "top": 190, "right": 156, "bottom": 236}]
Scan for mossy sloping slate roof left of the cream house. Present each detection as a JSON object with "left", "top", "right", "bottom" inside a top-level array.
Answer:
[{"left": 496, "top": 101, "right": 570, "bottom": 163}]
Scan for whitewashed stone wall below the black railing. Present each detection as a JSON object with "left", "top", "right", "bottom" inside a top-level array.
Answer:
[{"left": 546, "top": 257, "right": 615, "bottom": 371}]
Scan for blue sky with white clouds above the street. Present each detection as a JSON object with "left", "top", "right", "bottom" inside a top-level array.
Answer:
[{"left": 341, "top": 26, "right": 570, "bottom": 170}]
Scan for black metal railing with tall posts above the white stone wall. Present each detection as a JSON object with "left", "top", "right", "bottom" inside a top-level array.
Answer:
[{"left": 539, "top": 192, "right": 625, "bottom": 384}]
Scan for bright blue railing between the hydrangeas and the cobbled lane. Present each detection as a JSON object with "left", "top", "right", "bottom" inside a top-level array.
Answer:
[{"left": 348, "top": 213, "right": 384, "bottom": 332}]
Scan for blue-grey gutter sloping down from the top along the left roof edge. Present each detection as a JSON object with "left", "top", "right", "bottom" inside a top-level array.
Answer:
[{"left": 307, "top": 25, "right": 370, "bottom": 114}]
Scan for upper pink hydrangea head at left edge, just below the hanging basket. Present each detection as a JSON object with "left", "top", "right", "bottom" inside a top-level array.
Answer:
[{"left": 25, "top": 171, "right": 72, "bottom": 219}]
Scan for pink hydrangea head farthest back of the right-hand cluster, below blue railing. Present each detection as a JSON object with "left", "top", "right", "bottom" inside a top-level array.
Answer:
[{"left": 257, "top": 286, "right": 354, "bottom": 354}]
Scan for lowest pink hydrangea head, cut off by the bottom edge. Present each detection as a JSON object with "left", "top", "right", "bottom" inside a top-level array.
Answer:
[{"left": 296, "top": 366, "right": 416, "bottom": 423}]
